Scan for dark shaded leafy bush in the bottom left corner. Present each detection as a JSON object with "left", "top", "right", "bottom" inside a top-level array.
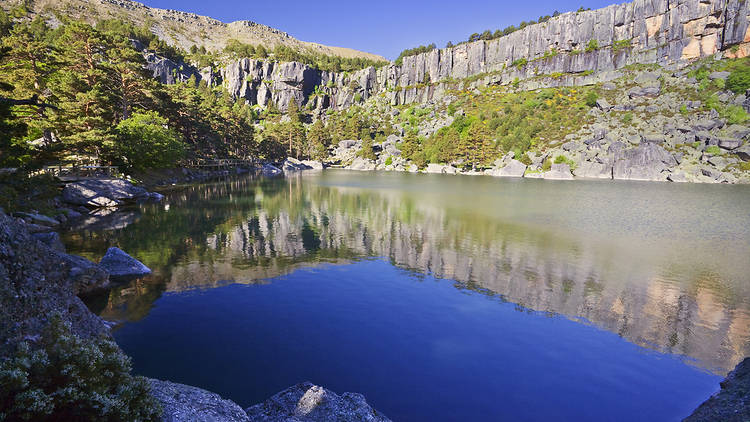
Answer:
[{"left": 0, "top": 318, "right": 161, "bottom": 421}]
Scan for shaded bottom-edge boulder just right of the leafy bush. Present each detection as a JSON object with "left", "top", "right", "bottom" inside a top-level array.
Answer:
[{"left": 149, "top": 379, "right": 251, "bottom": 422}]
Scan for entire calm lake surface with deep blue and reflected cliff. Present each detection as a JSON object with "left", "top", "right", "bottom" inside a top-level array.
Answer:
[{"left": 66, "top": 171, "right": 750, "bottom": 421}]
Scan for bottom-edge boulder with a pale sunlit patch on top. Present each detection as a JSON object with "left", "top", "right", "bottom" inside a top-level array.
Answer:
[{"left": 246, "top": 382, "right": 390, "bottom": 422}]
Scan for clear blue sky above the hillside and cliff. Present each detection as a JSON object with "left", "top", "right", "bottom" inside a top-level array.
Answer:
[{"left": 139, "top": 0, "right": 623, "bottom": 59}]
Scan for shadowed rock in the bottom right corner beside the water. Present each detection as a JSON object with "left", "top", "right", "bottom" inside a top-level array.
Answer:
[{"left": 685, "top": 358, "right": 750, "bottom": 422}]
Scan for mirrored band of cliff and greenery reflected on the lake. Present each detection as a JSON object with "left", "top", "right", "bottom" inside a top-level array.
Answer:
[{"left": 70, "top": 174, "right": 750, "bottom": 371}]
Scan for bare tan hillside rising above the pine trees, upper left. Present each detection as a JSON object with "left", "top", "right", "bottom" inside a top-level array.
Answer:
[{"left": 23, "top": 0, "right": 385, "bottom": 60}]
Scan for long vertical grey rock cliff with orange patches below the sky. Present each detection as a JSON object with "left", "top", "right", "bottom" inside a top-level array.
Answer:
[{"left": 214, "top": 0, "right": 750, "bottom": 110}]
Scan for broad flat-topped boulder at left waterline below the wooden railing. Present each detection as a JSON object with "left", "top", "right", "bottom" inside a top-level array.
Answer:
[{"left": 62, "top": 179, "right": 149, "bottom": 208}]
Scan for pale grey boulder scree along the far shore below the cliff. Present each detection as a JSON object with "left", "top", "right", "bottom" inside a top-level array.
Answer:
[{"left": 326, "top": 67, "right": 750, "bottom": 184}]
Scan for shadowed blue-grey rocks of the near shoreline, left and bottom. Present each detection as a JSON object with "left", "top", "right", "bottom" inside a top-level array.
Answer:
[{"left": 0, "top": 176, "right": 396, "bottom": 422}]
